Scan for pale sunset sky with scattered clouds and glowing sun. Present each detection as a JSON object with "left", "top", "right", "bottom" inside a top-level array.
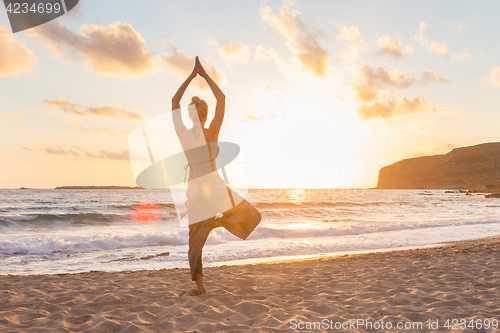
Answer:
[{"left": 0, "top": 0, "right": 500, "bottom": 188}]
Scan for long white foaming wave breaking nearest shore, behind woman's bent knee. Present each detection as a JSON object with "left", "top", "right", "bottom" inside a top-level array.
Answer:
[{"left": 0, "top": 216, "right": 500, "bottom": 255}]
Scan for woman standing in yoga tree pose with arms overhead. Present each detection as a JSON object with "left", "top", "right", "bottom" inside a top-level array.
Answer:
[{"left": 172, "top": 57, "right": 261, "bottom": 294}]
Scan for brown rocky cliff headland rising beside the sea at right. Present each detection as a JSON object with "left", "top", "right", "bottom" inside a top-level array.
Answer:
[{"left": 377, "top": 142, "right": 500, "bottom": 191}]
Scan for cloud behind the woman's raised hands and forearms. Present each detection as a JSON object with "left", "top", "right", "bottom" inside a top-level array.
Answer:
[{"left": 161, "top": 45, "right": 222, "bottom": 90}]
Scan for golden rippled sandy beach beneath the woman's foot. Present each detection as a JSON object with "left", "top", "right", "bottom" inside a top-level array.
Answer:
[{"left": 0, "top": 237, "right": 500, "bottom": 332}]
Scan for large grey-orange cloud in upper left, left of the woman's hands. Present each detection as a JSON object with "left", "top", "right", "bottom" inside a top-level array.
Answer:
[{"left": 30, "top": 21, "right": 157, "bottom": 77}]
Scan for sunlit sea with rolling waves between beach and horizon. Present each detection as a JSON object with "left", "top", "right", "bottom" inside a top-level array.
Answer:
[{"left": 0, "top": 189, "right": 500, "bottom": 275}]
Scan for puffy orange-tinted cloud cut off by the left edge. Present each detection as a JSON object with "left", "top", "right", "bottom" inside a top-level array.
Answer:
[{"left": 0, "top": 25, "right": 38, "bottom": 77}]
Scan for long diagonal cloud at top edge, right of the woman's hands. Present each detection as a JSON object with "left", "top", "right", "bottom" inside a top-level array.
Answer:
[{"left": 260, "top": 0, "right": 329, "bottom": 77}]
